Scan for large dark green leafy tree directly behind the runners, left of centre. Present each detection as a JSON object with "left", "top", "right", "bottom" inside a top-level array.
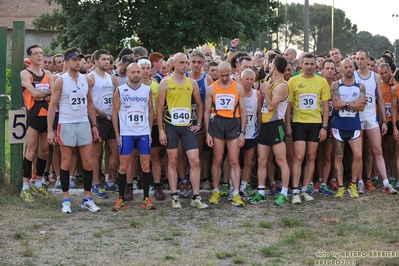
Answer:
[{"left": 33, "top": 0, "right": 282, "bottom": 54}]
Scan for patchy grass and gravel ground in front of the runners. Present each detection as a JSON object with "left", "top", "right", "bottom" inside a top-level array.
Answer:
[{"left": 0, "top": 184, "right": 399, "bottom": 265}]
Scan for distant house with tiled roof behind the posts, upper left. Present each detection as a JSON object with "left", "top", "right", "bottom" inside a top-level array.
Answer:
[{"left": 0, "top": 0, "right": 59, "bottom": 56}]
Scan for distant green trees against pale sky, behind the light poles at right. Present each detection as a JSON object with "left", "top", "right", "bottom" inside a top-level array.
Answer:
[{"left": 280, "top": 3, "right": 392, "bottom": 56}]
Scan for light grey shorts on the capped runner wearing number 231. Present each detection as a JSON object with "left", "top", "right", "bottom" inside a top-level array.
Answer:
[{"left": 57, "top": 121, "right": 93, "bottom": 147}]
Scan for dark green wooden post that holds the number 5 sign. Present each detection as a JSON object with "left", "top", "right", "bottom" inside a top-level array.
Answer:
[{"left": 10, "top": 21, "right": 25, "bottom": 187}]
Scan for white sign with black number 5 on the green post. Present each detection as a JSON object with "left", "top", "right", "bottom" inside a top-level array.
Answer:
[{"left": 8, "top": 110, "right": 26, "bottom": 144}]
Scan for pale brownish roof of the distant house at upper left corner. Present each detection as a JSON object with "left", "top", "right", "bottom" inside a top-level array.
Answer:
[{"left": 0, "top": 0, "right": 59, "bottom": 29}]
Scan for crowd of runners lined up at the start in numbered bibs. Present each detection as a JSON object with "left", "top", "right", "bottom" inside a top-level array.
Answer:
[{"left": 21, "top": 39, "right": 399, "bottom": 213}]
